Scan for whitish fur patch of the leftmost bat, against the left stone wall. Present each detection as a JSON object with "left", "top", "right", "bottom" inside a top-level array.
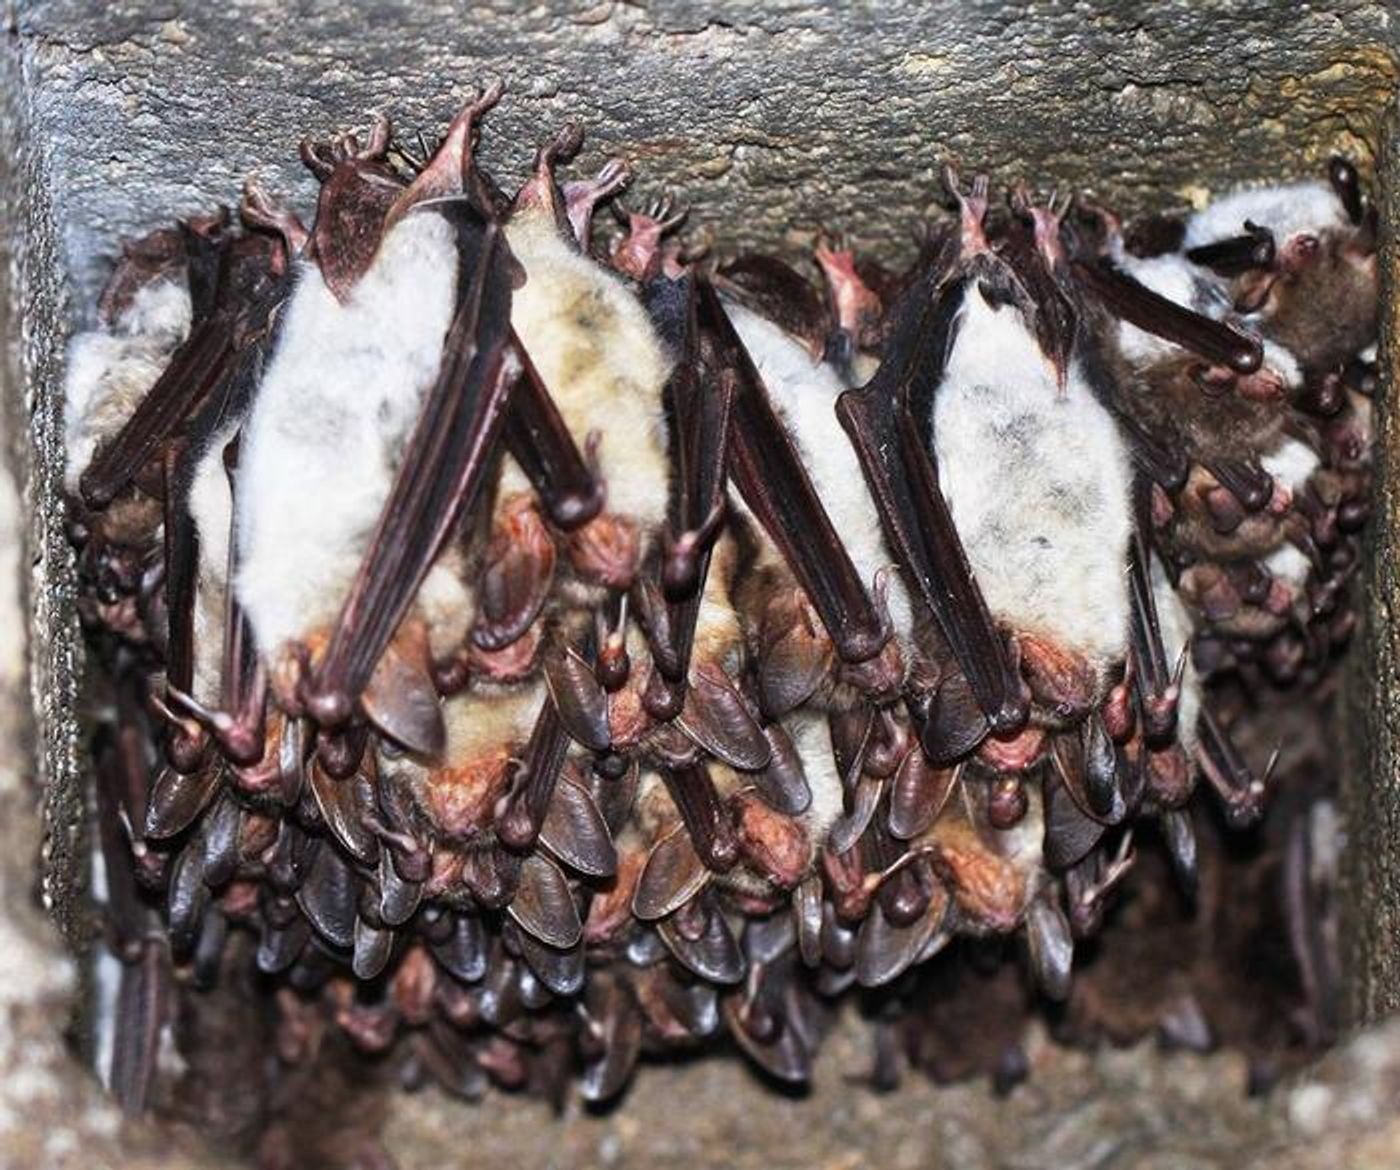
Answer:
[{"left": 63, "top": 280, "right": 190, "bottom": 491}]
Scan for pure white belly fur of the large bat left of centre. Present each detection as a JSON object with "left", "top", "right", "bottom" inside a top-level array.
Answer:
[{"left": 237, "top": 211, "right": 458, "bottom": 654}]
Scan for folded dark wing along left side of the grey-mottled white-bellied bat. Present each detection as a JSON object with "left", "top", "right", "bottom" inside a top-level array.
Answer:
[{"left": 836, "top": 267, "right": 1026, "bottom": 738}]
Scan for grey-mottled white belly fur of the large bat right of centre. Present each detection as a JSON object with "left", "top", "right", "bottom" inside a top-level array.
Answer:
[{"left": 934, "top": 287, "right": 1131, "bottom": 665}]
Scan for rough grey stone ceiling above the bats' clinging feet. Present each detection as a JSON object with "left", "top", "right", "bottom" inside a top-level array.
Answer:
[{"left": 10, "top": 0, "right": 1396, "bottom": 313}]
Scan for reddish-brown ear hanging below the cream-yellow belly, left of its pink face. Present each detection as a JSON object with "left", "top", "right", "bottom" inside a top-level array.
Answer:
[{"left": 472, "top": 495, "right": 554, "bottom": 651}]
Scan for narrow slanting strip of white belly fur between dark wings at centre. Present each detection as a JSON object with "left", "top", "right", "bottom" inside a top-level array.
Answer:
[{"left": 725, "top": 296, "right": 911, "bottom": 635}]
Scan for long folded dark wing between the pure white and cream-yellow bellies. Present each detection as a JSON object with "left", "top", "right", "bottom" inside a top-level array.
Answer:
[{"left": 307, "top": 203, "right": 518, "bottom": 754}]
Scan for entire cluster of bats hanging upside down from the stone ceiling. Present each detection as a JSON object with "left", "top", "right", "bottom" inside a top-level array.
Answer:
[{"left": 67, "top": 82, "right": 1376, "bottom": 1125}]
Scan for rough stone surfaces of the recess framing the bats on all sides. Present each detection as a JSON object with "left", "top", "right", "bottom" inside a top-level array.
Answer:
[{"left": 0, "top": 0, "right": 1400, "bottom": 1170}]
